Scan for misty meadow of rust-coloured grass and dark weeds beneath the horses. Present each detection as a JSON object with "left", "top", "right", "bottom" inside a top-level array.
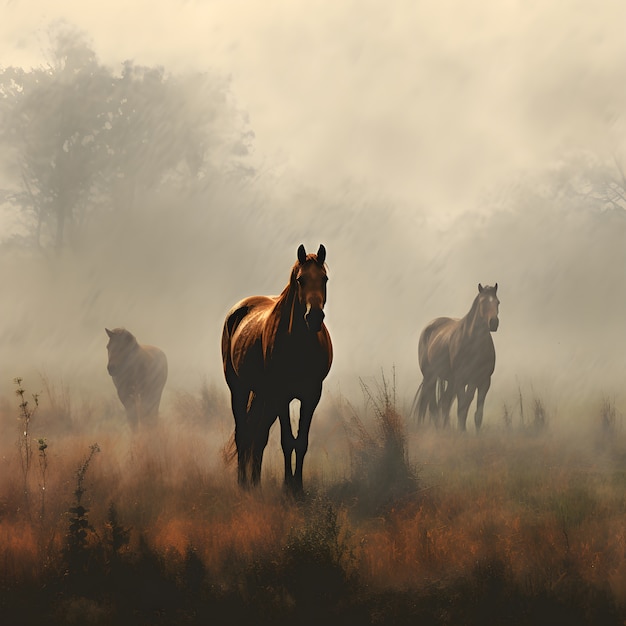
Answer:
[{"left": 0, "top": 378, "right": 626, "bottom": 625}]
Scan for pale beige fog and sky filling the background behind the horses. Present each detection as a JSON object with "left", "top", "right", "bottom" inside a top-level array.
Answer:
[{"left": 0, "top": 0, "right": 626, "bottom": 424}]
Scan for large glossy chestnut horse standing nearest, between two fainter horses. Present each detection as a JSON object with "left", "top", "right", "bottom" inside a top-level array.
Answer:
[{"left": 222, "top": 245, "right": 333, "bottom": 491}]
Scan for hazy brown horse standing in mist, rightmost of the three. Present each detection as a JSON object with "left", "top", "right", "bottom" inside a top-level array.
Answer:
[{"left": 413, "top": 283, "right": 500, "bottom": 431}]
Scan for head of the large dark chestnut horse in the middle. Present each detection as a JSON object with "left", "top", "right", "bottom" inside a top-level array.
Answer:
[{"left": 293, "top": 245, "right": 328, "bottom": 333}]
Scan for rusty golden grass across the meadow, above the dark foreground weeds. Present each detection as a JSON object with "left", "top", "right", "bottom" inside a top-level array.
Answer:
[{"left": 0, "top": 380, "right": 626, "bottom": 615}]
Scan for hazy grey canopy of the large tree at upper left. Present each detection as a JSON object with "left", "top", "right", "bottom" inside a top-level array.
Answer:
[{"left": 0, "top": 25, "right": 251, "bottom": 249}]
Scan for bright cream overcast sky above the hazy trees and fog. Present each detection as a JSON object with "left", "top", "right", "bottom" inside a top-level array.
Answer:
[{"left": 0, "top": 0, "right": 626, "bottom": 221}]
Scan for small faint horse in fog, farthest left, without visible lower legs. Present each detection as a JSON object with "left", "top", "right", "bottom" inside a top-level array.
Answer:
[{"left": 105, "top": 328, "right": 167, "bottom": 430}]
